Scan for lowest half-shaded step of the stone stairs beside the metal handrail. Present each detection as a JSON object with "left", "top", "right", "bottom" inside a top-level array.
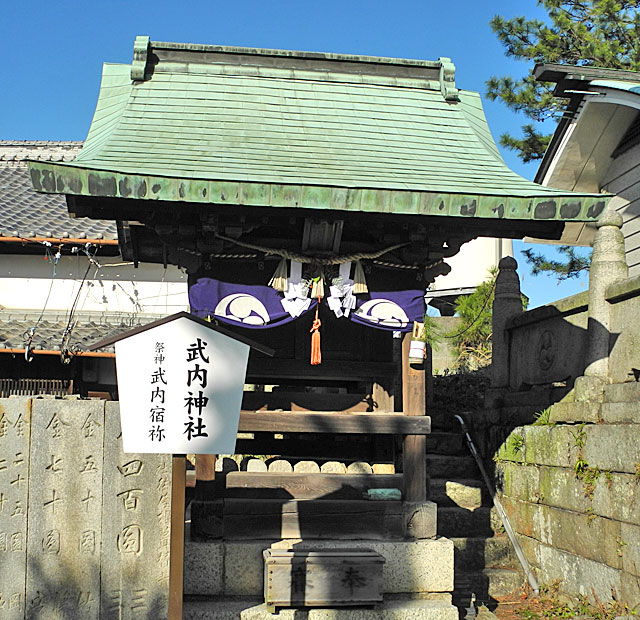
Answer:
[{"left": 453, "top": 568, "right": 526, "bottom": 606}]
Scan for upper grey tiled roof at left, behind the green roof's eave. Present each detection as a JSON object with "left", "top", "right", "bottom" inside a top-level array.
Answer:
[{"left": 0, "top": 140, "right": 117, "bottom": 239}]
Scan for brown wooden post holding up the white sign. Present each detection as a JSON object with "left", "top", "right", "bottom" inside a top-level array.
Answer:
[{"left": 169, "top": 454, "right": 187, "bottom": 620}]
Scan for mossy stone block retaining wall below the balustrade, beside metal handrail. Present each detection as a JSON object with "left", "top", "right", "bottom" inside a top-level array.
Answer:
[{"left": 484, "top": 392, "right": 640, "bottom": 606}]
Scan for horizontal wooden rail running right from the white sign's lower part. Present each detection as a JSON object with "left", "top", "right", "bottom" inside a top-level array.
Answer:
[{"left": 238, "top": 411, "right": 431, "bottom": 435}]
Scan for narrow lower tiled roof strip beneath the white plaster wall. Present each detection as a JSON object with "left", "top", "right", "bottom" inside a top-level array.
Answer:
[{"left": 0, "top": 309, "right": 159, "bottom": 353}]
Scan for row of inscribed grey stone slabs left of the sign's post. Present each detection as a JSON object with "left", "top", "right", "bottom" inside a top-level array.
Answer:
[{"left": 0, "top": 397, "right": 172, "bottom": 620}]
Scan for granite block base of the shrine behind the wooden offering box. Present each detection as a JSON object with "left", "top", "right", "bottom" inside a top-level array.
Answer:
[{"left": 184, "top": 538, "right": 453, "bottom": 600}]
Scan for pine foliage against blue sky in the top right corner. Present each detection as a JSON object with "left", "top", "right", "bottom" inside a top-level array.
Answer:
[{"left": 487, "top": 0, "right": 640, "bottom": 162}]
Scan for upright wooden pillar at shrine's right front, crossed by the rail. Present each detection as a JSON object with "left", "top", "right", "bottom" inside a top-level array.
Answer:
[{"left": 402, "top": 334, "right": 427, "bottom": 502}]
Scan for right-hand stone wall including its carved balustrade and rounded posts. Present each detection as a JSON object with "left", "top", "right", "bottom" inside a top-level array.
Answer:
[{"left": 482, "top": 225, "right": 640, "bottom": 607}]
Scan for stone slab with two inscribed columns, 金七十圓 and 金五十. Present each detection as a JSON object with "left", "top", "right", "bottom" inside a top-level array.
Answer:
[{"left": 27, "top": 398, "right": 104, "bottom": 620}]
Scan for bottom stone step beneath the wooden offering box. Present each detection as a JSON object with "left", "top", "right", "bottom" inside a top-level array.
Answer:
[{"left": 182, "top": 599, "right": 459, "bottom": 620}]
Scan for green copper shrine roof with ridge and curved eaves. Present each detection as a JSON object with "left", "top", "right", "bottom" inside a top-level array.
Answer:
[{"left": 30, "top": 37, "right": 608, "bottom": 221}]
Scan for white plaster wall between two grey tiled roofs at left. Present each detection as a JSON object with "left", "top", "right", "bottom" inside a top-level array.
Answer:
[{"left": 0, "top": 255, "right": 189, "bottom": 314}]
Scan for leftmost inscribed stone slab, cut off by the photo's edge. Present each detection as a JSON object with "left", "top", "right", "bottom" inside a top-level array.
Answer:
[{"left": 0, "top": 398, "right": 31, "bottom": 620}]
